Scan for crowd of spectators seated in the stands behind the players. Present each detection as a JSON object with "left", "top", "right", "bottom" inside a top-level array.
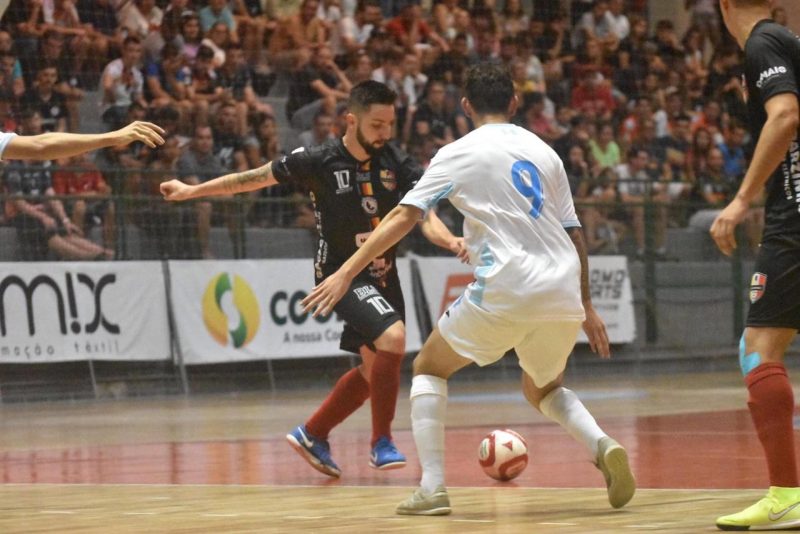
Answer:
[{"left": 0, "top": 0, "right": 786, "bottom": 259}]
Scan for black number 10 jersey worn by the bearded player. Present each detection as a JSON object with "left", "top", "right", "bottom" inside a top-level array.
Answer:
[{"left": 272, "top": 139, "right": 423, "bottom": 285}]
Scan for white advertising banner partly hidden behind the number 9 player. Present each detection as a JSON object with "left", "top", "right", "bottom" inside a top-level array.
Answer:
[{"left": 415, "top": 256, "right": 636, "bottom": 343}]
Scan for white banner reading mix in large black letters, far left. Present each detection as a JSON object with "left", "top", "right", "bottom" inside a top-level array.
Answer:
[{"left": 0, "top": 262, "right": 170, "bottom": 363}]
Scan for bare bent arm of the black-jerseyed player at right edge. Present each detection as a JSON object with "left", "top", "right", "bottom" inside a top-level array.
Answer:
[{"left": 709, "top": 93, "right": 800, "bottom": 256}]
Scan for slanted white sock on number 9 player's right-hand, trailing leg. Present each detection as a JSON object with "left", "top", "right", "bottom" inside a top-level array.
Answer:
[{"left": 539, "top": 387, "right": 606, "bottom": 462}]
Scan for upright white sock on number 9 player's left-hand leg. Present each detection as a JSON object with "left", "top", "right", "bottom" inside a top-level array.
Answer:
[{"left": 410, "top": 375, "right": 447, "bottom": 493}]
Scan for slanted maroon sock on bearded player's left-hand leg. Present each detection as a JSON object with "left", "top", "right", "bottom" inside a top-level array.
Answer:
[{"left": 306, "top": 367, "right": 369, "bottom": 439}]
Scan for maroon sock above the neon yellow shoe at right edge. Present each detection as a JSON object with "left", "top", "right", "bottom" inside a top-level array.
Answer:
[{"left": 744, "top": 363, "right": 798, "bottom": 488}]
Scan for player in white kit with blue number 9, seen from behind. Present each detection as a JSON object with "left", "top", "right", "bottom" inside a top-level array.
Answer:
[{"left": 303, "top": 64, "right": 636, "bottom": 515}]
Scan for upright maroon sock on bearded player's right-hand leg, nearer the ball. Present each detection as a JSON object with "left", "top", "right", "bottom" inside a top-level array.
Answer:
[{"left": 369, "top": 350, "right": 403, "bottom": 445}]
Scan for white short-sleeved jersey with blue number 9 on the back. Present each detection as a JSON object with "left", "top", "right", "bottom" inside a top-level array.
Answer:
[{"left": 403, "top": 124, "right": 583, "bottom": 319}]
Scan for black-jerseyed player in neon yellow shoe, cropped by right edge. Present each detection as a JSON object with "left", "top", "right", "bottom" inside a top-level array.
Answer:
[{"left": 711, "top": 0, "right": 800, "bottom": 530}]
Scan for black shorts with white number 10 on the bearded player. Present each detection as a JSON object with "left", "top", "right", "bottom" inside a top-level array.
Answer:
[{"left": 334, "top": 276, "right": 406, "bottom": 354}]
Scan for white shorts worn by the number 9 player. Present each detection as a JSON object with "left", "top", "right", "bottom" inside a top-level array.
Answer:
[{"left": 438, "top": 298, "right": 583, "bottom": 387}]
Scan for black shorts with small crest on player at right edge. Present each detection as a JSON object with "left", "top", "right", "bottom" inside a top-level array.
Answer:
[{"left": 747, "top": 238, "right": 800, "bottom": 330}]
